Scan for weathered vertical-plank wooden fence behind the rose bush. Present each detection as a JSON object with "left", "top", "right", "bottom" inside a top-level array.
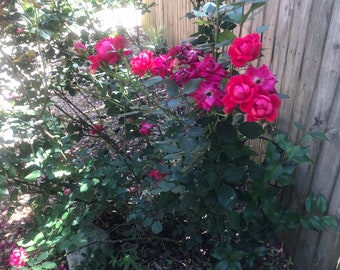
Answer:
[{"left": 143, "top": 0, "right": 340, "bottom": 270}]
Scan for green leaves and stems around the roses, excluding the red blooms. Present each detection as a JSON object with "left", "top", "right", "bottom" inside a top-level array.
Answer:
[{"left": 0, "top": 0, "right": 337, "bottom": 269}]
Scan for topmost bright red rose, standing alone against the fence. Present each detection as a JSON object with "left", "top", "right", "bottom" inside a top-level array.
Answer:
[{"left": 228, "top": 33, "right": 262, "bottom": 67}]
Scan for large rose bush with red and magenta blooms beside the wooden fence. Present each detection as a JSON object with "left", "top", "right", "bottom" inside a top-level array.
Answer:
[{"left": 0, "top": 1, "right": 336, "bottom": 269}]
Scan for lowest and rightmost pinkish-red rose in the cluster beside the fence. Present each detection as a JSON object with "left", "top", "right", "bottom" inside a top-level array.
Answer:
[{"left": 246, "top": 89, "right": 281, "bottom": 122}]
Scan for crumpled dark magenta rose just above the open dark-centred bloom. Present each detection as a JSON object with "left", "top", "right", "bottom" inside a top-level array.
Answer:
[{"left": 195, "top": 53, "right": 227, "bottom": 82}]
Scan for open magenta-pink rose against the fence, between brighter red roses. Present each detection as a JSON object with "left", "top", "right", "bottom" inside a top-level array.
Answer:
[{"left": 246, "top": 65, "right": 277, "bottom": 94}]
